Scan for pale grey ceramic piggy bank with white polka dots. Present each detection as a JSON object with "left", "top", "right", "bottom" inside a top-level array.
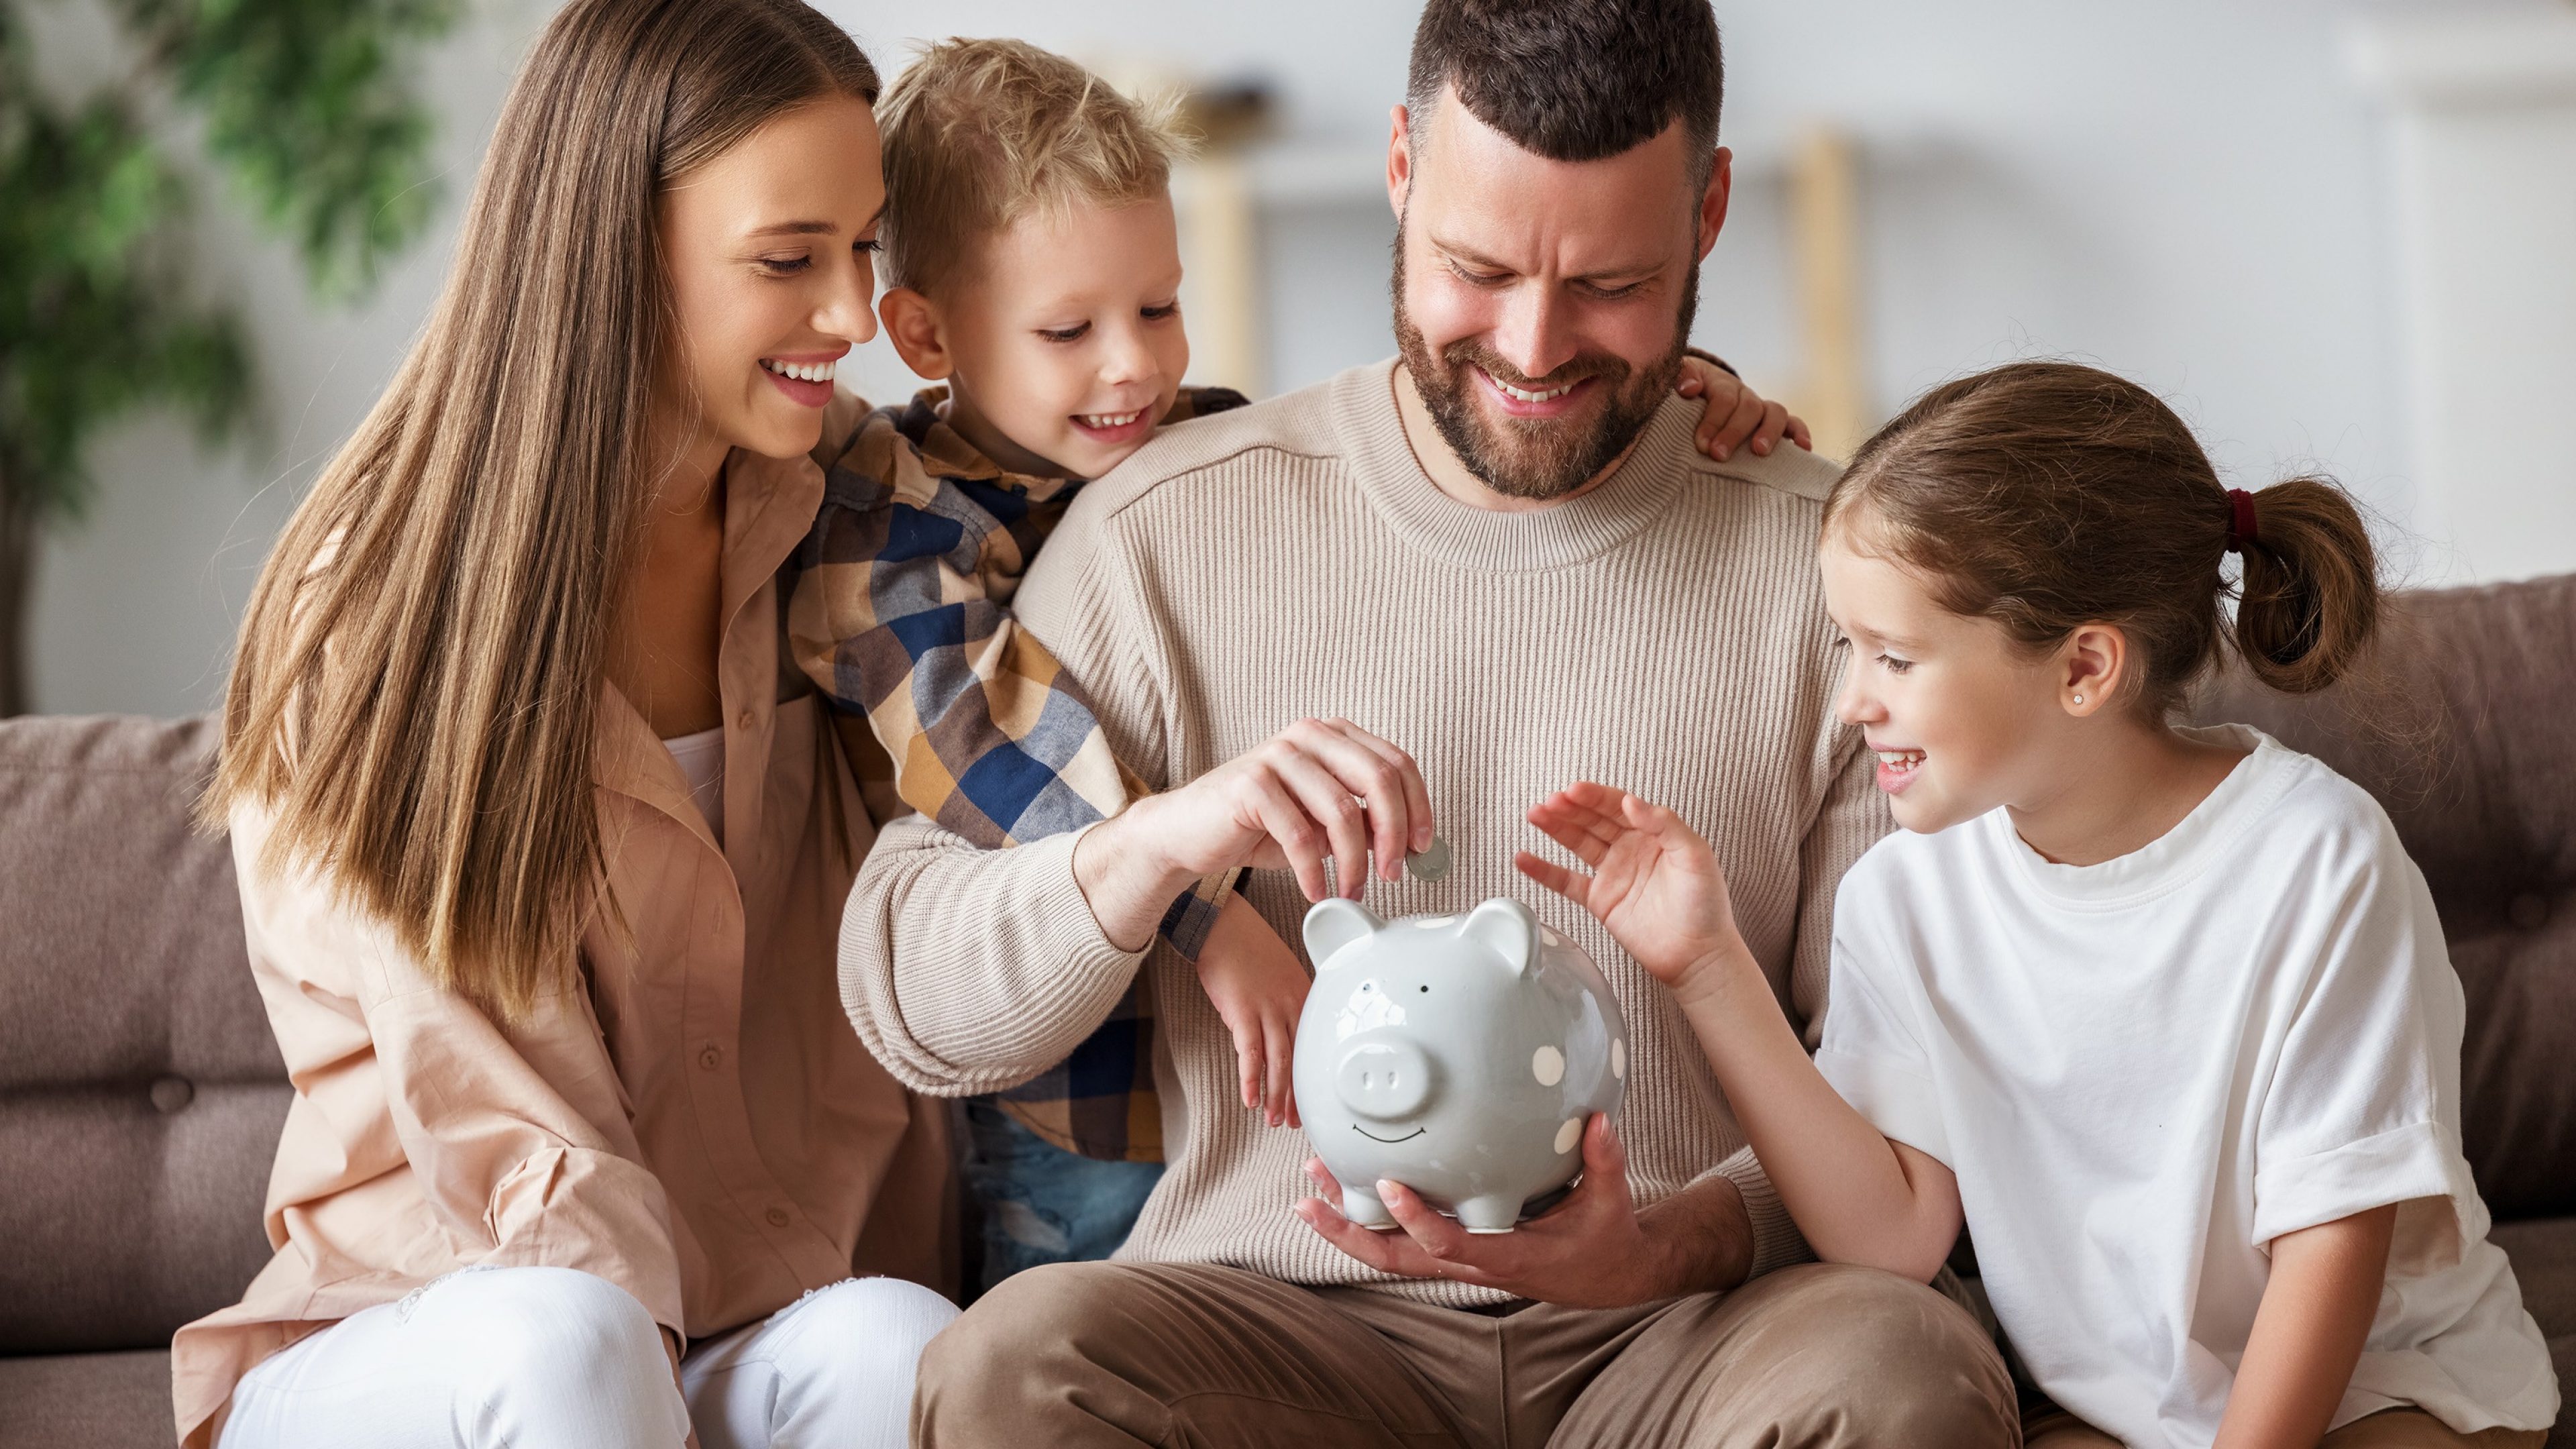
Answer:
[{"left": 1296, "top": 898, "right": 1628, "bottom": 1232}]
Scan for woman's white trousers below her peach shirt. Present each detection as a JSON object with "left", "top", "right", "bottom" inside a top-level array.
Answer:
[{"left": 219, "top": 1269, "right": 958, "bottom": 1449}]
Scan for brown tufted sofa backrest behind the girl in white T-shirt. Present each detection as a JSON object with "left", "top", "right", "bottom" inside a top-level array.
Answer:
[{"left": 2195, "top": 575, "right": 2576, "bottom": 1220}]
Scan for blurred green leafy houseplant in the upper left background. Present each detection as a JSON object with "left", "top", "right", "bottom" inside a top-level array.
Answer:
[{"left": 0, "top": 0, "right": 453, "bottom": 716}]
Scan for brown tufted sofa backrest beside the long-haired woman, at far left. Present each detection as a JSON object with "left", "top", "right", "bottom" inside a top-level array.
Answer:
[{"left": 0, "top": 719, "right": 291, "bottom": 1350}]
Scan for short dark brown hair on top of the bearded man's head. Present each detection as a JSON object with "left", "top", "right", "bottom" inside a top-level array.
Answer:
[{"left": 1404, "top": 0, "right": 1726, "bottom": 175}]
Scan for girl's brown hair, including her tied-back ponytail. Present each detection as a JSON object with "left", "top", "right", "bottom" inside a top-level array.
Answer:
[{"left": 1824, "top": 361, "right": 2380, "bottom": 719}]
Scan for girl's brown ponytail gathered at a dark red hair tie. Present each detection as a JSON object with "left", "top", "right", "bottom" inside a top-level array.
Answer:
[{"left": 2229, "top": 477, "right": 2380, "bottom": 694}]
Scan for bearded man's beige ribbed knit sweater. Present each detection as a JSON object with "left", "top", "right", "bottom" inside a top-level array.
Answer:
[{"left": 840, "top": 361, "right": 1888, "bottom": 1305}]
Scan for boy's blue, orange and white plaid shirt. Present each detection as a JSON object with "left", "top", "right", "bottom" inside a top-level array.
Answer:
[{"left": 788, "top": 387, "right": 1244, "bottom": 1163}]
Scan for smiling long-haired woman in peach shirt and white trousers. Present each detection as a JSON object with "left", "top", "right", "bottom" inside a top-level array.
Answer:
[{"left": 172, "top": 0, "right": 953, "bottom": 1446}]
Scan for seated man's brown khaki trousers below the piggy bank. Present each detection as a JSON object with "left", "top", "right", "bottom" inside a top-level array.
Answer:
[{"left": 912, "top": 1263, "right": 2022, "bottom": 1449}]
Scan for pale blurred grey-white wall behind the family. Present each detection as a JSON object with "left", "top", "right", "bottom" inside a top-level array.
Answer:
[{"left": 34, "top": 0, "right": 2576, "bottom": 714}]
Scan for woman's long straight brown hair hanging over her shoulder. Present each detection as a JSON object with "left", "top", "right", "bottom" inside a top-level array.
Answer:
[{"left": 201, "top": 0, "right": 878, "bottom": 1016}]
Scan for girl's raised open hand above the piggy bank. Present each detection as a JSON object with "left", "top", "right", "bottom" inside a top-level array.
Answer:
[{"left": 1512, "top": 782, "right": 1744, "bottom": 987}]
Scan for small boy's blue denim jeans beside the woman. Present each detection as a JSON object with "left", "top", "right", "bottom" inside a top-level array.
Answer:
[{"left": 966, "top": 1098, "right": 1162, "bottom": 1302}]
